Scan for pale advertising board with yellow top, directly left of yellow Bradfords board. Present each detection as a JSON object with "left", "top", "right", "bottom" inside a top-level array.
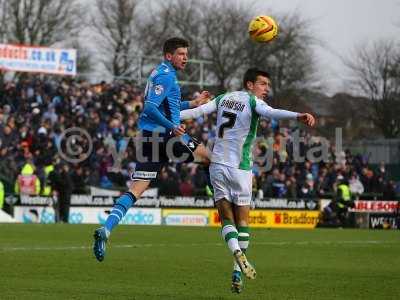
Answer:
[{"left": 162, "top": 209, "right": 209, "bottom": 226}]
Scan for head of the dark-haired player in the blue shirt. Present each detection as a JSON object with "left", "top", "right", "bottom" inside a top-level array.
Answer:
[{"left": 163, "top": 37, "right": 189, "bottom": 70}]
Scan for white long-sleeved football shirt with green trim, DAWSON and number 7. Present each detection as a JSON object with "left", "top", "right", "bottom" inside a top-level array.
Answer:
[{"left": 181, "top": 91, "right": 298, "bottom": 170}]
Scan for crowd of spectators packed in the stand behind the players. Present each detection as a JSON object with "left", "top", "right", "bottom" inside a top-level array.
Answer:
[{"left": 0, "top": 77, "right": 396, "bottom": 199}]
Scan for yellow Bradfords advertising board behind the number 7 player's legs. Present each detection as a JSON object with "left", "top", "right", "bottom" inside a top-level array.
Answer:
[{"left": 209, "top": 209, "right": 320, "bottom": 229}]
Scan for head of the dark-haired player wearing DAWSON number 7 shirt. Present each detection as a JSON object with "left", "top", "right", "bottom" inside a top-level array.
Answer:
[{"left": 243, "top": 68, "right": 271, "bottom": 99}]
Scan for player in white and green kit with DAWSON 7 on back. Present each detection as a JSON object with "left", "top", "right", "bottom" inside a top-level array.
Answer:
[{"left": 181, "top": 69, "right": 315, "bottom": 293}]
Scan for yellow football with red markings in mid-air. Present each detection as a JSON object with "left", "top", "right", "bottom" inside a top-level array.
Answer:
[{"left": 249, "top": 16, "right": 278, "bottom": 43}]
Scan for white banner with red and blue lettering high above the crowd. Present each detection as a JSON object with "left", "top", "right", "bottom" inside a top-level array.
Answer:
[{"left": 0, "top": 44, "right": 76, "bottom": 75}]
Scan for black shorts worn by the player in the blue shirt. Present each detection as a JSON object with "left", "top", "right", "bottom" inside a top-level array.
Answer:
[{"left": 131, "top": 130, "right": 199, "bottom": 180}]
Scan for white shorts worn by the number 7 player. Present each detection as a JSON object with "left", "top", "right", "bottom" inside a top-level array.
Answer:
[{"left": 210, "top": 163, "right": 253, "bottom": 206}]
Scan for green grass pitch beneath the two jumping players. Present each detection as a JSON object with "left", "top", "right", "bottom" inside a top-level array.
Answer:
[{"left": 0, "top": 224, "right": 400, "bottom": 300}]
